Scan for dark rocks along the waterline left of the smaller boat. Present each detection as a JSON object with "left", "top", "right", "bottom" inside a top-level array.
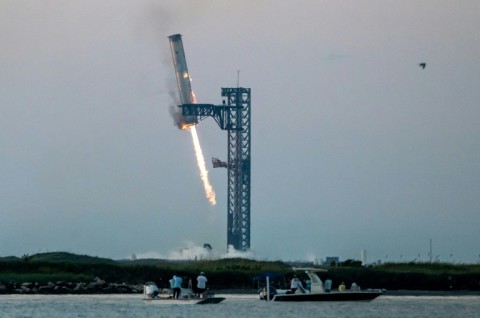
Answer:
[{"left": 0, "top": 277, "right": 143, "bottom": 294}]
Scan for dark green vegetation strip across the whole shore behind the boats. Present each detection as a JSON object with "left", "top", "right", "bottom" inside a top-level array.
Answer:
[{"left": 0, "top": 252, "right": 480, "bottom": 290}]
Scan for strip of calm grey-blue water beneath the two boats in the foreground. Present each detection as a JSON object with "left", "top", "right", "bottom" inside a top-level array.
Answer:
[{"left": 0, "top": 295, "right": 480, "bottom": 318}]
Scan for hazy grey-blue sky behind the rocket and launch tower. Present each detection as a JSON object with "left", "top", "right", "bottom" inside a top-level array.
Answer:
[{"left": 0, "top": 0, "right": 480, "bottom": 263}]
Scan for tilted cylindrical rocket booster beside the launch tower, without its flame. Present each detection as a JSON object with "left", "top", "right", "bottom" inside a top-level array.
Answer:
[{"left": 168, "top": 34, "right": 198, "bottom": 125}]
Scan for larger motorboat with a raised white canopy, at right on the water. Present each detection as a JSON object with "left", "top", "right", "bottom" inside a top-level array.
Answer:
[{"left": 260, "top": 268, "right": 384, "bottom": 301}]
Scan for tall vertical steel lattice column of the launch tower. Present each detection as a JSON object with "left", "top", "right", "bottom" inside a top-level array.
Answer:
[{"left": 222, "top": 87, "right": 251, "bottom": 251}]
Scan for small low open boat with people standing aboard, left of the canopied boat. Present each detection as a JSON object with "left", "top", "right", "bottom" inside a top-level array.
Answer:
[{"left": 143, "top": 284, "right": 225, "bottom": 305}]
